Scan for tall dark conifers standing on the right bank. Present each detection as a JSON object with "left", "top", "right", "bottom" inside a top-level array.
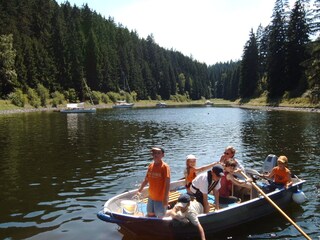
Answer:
[{"left": 239, "top": 0, "right": 320, "bottom": 102}]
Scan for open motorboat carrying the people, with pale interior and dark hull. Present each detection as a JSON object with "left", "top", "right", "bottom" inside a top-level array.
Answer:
[{"left": 97, "top": 157, "right": 305, "bottom": 238}]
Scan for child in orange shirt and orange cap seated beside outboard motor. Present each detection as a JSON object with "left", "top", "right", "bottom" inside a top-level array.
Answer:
[{"left": 264, "top": 156, "right": 292, "bottom": 189}]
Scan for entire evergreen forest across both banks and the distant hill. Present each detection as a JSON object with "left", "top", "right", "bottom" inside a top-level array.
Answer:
[{"left": 0, "top": 0, "right": 320, "bottom": 107}]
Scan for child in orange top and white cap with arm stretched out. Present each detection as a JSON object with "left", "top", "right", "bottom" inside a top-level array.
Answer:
[{"left": 184, "top": 154, "right": 216, "bottom": 190}]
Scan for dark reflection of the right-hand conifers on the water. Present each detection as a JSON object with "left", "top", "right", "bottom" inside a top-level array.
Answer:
[{"left": 240, "top": 110, "right": 320, "bottom": 172}]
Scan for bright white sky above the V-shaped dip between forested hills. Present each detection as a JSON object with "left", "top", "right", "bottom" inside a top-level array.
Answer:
[{"left": 56, "top": 0, "right": 275, "bottom": 65}]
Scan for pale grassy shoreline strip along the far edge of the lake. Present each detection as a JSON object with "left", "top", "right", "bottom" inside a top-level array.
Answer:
[{"left": 0, "top": 102, "right": 320, "bottom": 115}]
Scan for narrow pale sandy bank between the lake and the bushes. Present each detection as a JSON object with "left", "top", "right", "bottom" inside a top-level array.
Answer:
[{"left": 0, "top": 103, "right": 320, "bottom": 115}]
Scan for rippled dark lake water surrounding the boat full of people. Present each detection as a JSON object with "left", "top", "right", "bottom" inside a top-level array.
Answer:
[{"left": 0, "top": 107, "right": 320, "bottom": 240}]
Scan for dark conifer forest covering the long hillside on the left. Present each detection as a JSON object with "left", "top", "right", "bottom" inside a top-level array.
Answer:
[{"left": 0, "top": 0, "right": 215, "bottom": 99}]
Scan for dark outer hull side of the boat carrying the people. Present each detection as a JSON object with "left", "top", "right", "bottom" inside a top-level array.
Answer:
[{"left": 98, "top": 180, "right": 304, "bottom": 238}]
